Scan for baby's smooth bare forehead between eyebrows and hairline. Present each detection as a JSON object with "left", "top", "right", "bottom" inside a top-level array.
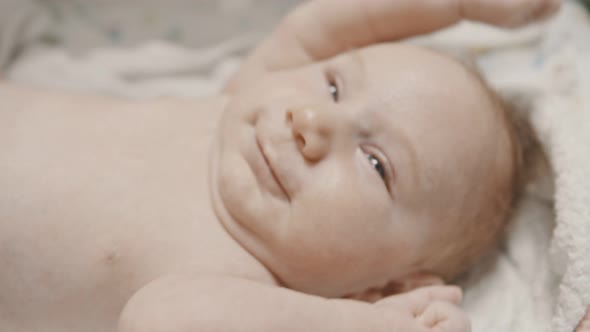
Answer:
[{"left": 328, "top": 43, "right": 498, "bottom": 142}]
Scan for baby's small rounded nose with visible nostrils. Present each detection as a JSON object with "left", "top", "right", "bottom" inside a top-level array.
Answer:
[{"left": 286, "top": 107, "right": 334, "bottom": 161}]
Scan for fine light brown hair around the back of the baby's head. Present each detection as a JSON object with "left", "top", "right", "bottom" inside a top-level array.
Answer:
[{"left": 426, "top": 49, "right": 544, "bottom": 281}]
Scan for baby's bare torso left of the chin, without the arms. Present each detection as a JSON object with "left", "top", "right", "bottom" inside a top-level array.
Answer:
[{"left": 0, "top": 86, "right": 272, "bottom": 332}]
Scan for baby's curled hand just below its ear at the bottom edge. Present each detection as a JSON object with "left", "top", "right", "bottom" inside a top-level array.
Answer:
[{"left": 374, "top": 286, "right": 471, "bottom": 332}]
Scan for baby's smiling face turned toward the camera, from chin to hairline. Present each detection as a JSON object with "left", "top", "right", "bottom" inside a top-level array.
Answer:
[{"left": 212, "top": 44, "right": 510, "bottom": 296}]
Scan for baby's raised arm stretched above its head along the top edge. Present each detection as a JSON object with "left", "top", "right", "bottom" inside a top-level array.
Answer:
[{"left": 226, "top": 0, "right": 560, "bottom": 92}]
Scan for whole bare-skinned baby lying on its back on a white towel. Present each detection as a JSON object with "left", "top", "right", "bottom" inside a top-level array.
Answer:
[{"left": 0, "top": 0, "right": 553, "bottom": 332}]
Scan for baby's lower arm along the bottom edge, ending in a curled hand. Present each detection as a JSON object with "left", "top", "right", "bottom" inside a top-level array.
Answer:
[{"left": 119, "top": 276, "right": 469, "bottom": 332}]
